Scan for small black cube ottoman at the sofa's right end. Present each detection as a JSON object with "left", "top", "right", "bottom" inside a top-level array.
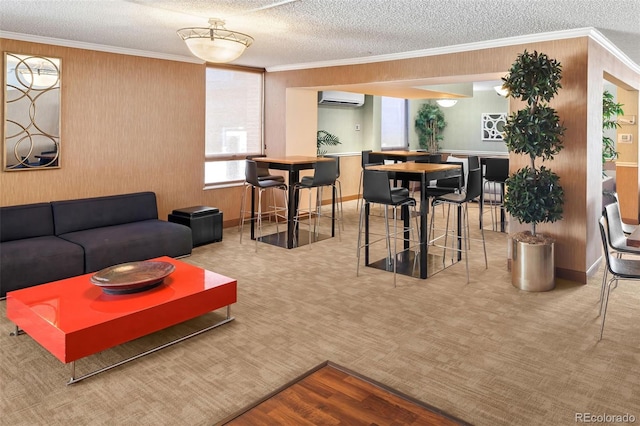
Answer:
[{"left": 169, "top": 206, "right": 222, "bottom": 247}]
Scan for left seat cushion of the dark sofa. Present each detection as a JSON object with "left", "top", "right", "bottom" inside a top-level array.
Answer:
[{"left": 0, "top": 236, "right": 84, "bottom": 297}]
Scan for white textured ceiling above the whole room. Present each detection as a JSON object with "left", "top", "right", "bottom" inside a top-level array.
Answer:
[{"left": 0, "top": 0, "right": 640, "bottom": 69}]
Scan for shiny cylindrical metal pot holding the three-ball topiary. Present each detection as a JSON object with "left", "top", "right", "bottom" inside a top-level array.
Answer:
[{"left": 511, "top": 239, "right": 556, "bottom": 291}]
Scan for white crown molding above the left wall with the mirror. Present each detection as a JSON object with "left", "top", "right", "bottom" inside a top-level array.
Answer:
[{"left": 0, "top": 31, "right": 204, "bottom": 64}]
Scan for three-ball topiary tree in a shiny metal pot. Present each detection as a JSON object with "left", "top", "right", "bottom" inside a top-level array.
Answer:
[{"left": 502, "top": 50, "right": 565, "bottom": 291}]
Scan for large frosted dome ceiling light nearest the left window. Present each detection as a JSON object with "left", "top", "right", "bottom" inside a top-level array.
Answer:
[{"left": 177, "top": 18, "right": 253, "bottom": 63}]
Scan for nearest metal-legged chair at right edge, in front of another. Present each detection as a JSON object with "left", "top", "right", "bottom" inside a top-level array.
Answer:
[{"left": 598, "top": 217, "right": 640, "bottom": 341}]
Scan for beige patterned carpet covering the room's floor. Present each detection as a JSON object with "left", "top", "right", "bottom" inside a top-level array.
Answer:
[{"left": 0, "top": 202, "right": 640, "bottom": 425}]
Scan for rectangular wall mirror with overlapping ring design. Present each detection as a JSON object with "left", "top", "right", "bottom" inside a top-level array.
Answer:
[{"left": 3, "top": 53, "right": 61, "bottom": 171}]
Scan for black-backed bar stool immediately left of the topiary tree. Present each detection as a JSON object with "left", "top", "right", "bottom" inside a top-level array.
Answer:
[{"left": 480, "top": 158, "right": 509, "bottom": 231}]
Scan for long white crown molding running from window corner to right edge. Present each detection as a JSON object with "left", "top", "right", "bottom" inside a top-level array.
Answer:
[{"left": 266, "top": 27, "right": 640, "bottom": 73}]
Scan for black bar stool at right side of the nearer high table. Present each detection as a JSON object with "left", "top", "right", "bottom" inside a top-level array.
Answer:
[{"left": 429, "top": 167, "right": 488, "bottom": 282}]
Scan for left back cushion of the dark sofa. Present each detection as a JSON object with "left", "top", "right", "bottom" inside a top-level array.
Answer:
[{"left": 0, "top": 203, "right": 53, "bottom": 242}]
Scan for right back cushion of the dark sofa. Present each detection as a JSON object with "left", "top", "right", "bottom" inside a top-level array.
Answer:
[{"left": 51, "top": 192, "right": 158, "bottom": 235}]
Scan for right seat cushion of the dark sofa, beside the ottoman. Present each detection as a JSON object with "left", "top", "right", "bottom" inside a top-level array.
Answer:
[{"left": 59, "top": 219, "right": 192, "bottom": 273}]
